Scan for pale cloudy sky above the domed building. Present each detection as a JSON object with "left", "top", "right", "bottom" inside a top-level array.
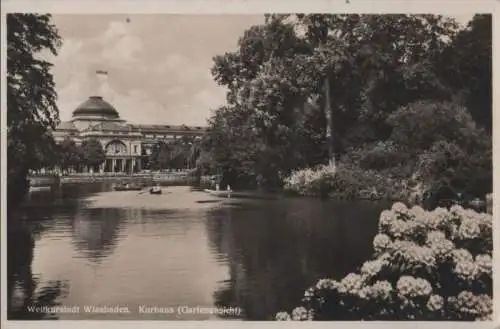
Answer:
[{"left": 51, "top": 14, "right": 471, "bottom": 126}]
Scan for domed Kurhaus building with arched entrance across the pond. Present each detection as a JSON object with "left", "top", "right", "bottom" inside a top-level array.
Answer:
[{"left": 54, "top": 96, "right": 205, "bottom": 172}]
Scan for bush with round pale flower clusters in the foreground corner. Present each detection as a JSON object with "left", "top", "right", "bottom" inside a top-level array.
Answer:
[{"left": 276, "top": 202, "right": 493, "bottom": 321}]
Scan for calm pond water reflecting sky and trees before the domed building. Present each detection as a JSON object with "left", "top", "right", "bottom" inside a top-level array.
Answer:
[{"left": 8, "top": 183, "right": 390, "bottom": 320}]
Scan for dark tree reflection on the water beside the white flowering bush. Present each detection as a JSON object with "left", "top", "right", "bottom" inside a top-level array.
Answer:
[{"left": 207, "top": 199, "right": 392, "bottom": 320}]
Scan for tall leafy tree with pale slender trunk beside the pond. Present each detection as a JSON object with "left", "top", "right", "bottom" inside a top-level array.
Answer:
[{"left": 209, "top": 15, "right": 457, "bottom": 190}]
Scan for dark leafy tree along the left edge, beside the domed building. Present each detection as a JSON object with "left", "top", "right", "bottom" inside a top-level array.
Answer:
[{"left": 7, "top": 14, "right": 61, "bottom": 205}]
